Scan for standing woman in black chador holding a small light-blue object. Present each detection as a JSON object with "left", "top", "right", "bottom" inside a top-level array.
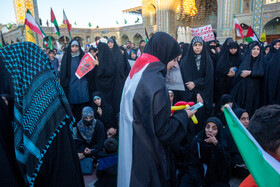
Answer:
[{"left": 214, "top": 42, "right": 242, "bottom": 103}]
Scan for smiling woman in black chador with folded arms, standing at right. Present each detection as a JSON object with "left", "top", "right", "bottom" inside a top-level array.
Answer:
[{"left": 231, "top": 43, "right": 264, "bottom": 116}]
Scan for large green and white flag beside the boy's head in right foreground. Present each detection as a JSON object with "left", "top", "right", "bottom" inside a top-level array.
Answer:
[{"left": 224, "top": 105, "right": 280, "bottom": 187}]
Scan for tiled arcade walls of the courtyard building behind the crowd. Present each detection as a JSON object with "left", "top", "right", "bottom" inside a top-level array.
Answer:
[{"left": 3, "top": 0, "right": 280, "bottom": 46}]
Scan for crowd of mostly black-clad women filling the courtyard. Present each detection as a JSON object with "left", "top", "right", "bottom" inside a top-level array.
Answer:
[{"left": 0, "top": 32, "right": 280, "bottom": 187}]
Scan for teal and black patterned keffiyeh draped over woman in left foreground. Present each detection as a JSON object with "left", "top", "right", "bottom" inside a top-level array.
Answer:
[{"left": 0, "top": 42, "right": 72, "bottom": 186}]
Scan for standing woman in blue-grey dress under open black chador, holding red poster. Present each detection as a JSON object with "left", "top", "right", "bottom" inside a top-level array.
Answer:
[{"left": 60, "top": 40, "right": 93, "bottom": 121}]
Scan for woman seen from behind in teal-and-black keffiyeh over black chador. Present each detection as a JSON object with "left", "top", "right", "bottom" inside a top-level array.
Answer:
[{"left": 0, "top": 42, "right": 84, "bottom": 186}]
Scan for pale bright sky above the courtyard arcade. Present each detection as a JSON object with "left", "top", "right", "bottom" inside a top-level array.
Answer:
[{"left": 0, "top": 0, "right": 142, "bottom": 28}]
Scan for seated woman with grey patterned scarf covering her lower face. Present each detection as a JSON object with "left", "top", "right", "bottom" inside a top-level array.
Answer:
[{"left": 75, "top": 107, "right": 106, "bottom": 159}]
